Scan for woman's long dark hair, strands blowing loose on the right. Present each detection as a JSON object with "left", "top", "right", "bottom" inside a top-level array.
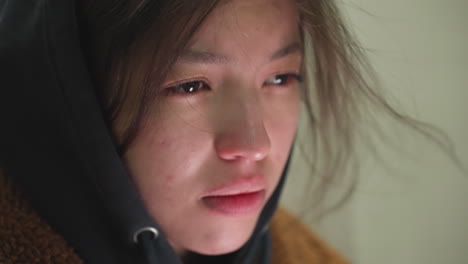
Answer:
[{"left": 77, "top": 0, "right": 458, "bottom": 210}]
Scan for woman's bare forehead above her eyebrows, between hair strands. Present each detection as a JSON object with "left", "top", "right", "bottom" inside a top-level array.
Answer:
[{"left": 189, "top": 0, "right": 300, "bottom": 63}]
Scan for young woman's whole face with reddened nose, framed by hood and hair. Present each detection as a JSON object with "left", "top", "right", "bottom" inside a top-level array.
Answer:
[{"left": 124, "top": 0, "right": 302, "bottom": 255}]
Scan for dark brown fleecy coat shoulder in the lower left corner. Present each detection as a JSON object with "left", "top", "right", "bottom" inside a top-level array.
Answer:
[{"left": 0, "top": 168, "right": 82, "bottom": 264}]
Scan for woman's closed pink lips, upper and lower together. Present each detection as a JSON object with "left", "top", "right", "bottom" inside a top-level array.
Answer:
[{"left": 201, "top": 175, "right": 266, "bottom": 215}]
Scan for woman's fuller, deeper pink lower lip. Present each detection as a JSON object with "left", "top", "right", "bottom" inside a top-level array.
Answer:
[{"left": 202, "top": 191, "right": 265, "bottom": 215}]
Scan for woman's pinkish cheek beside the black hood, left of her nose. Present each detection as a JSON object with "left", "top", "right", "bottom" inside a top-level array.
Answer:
[{"left": 124, "top": 116, "right": 206, "bottom": 197}]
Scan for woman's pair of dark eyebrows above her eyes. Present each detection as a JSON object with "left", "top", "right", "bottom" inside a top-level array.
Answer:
[{"left": 179, "top": 42, "right": 302, "bottom": 64}]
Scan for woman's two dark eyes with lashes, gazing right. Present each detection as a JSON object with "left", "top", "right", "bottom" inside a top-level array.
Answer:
[{"left": 165, "top": 73, "right": 302, "bottom": 96}]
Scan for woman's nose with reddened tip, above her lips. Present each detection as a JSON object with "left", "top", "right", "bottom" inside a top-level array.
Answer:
[{"left": 214, "top": 89, "right": 271, "bottom": 161}]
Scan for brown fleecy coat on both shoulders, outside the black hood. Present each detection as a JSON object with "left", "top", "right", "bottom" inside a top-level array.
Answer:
[{"left": 0, "top": 171, "right": 347, "bottom": 264}]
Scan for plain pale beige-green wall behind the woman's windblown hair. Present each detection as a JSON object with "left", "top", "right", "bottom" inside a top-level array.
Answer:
[{"left": 283, "top": 0, "right": 468, "bottom": 264}]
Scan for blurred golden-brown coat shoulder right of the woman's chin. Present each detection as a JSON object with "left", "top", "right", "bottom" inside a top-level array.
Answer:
[{"left": 270, "top": 208, "right": 349, "bottom": 264}]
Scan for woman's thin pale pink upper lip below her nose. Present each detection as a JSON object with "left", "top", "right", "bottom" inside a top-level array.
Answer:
[{"left": 202, "top": 174, "right": 266, "bottom": 198}]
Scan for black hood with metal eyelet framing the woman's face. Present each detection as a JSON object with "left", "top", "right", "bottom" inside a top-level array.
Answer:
[{"left": 0, "top": 0, "right": 289, "bottom": 264}]
